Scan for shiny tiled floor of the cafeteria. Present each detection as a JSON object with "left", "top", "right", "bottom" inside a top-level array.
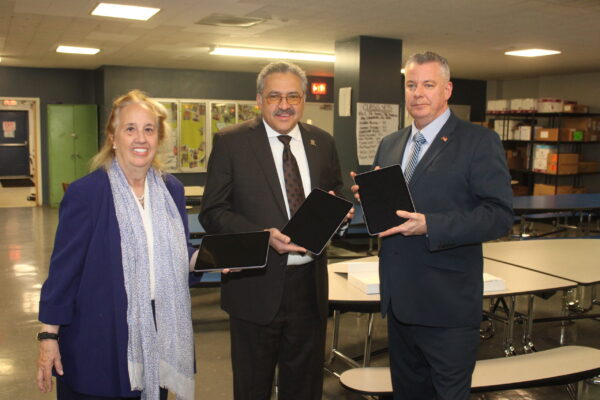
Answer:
[{"left": 0, "top": 208, "right": 600, "bottom": 400}]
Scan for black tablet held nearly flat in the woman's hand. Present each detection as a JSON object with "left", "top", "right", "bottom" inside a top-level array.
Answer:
[{"left": 194, "top": 231, "right": 270, "bottom": 271}]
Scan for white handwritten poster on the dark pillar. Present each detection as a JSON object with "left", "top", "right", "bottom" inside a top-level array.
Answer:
[{"left": 356, "top": 103, "right": 400, "bottom": 165}]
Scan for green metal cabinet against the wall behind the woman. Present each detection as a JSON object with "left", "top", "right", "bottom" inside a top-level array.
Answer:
[{"left": 48, "top": 104, "right": 98, "bottom": 207}]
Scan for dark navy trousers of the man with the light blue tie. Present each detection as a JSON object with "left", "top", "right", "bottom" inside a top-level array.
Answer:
[{"left": 387, "top": 309, "right": 479, "bottom": 400}]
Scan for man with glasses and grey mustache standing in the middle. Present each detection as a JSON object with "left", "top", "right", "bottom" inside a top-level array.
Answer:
[{"left": 200, "top": 62, "right": 342, "bottom": 400}]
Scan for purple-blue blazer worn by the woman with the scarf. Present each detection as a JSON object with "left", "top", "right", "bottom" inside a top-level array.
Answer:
[{"left": 39, "top": 169, "right": 193, "bottom": 397}]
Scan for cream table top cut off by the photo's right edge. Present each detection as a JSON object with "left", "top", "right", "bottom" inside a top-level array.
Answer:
[{"left": 483, "top": 239, "right": 600, "bottom": 285}]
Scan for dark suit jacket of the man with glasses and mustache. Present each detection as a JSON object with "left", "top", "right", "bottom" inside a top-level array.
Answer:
[{"left": 200, "top": 118, "right": 342, "bottom": 324}]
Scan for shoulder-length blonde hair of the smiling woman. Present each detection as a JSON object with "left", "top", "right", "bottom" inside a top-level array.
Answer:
[{"left": 90, "top": 89, "right": 170, "bottom": 171}]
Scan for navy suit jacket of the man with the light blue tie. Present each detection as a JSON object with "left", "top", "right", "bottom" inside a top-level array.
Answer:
[{"left": 374, "top": 114, "right": 513, "bottom": 327}]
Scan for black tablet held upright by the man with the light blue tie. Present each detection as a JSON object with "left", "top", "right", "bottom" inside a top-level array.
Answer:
[{"left": 354, "top": 165, "right": 415, "bottom": 235}]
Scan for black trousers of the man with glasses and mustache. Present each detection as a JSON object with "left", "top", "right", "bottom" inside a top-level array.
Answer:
[{"left": 230, "top": 263, "right": 327, "bottom": 400}]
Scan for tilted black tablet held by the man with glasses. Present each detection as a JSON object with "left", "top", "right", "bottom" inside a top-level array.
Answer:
[{"left": 281, "top": 189, "right": 352, "bottom": 255}]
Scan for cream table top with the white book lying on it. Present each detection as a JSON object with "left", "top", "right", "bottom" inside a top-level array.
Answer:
[{"left": 328, "top": 256, "right": 576, "bottom": 303}]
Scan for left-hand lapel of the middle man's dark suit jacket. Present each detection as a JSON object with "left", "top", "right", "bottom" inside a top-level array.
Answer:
[{"left": 248, "top": 118, "right": 288, "bottom": 219}]
